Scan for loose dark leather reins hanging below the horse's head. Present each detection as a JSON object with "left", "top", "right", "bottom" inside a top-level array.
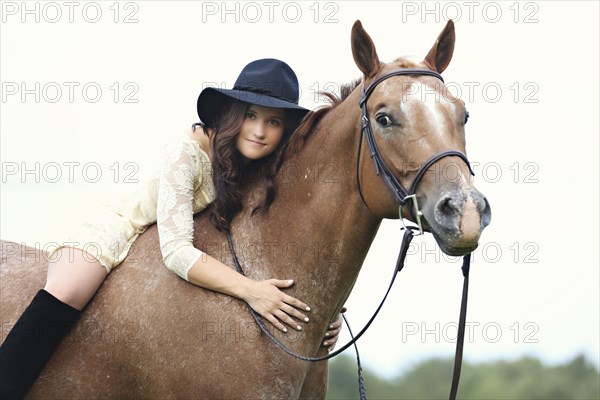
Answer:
[{"left": 227, "top": 226, "right": 471, "bottom": 400}]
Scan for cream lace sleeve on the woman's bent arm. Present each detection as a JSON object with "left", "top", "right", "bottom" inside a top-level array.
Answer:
[{"left": 156, "top": 141, "right": 203, "bottom": 280}]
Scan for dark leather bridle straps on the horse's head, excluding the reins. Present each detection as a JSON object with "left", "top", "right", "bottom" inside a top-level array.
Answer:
[{"left": 356, "top": 68, "right": 474, "bottom": 235}]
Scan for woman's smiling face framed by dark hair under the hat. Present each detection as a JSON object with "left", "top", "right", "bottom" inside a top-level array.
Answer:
[{"left": 236, "top": 104, "right": 285, "bottom": 161}]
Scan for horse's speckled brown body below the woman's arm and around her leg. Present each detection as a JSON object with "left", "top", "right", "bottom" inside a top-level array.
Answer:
[{"left": 0, "top": 220, "right": 314, "bottom": 399}]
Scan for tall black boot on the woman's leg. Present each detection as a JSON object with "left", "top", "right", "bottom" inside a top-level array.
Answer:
[{"left": 0, "top": 290, "right": 81, "bottom": 400}]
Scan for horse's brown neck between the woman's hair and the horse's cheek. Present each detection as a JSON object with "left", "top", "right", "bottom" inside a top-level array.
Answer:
[{"left": 238, "top": 86, "right": 380, "bottom": 332}]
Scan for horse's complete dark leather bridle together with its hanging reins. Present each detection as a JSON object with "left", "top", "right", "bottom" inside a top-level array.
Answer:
[{"left": 227, "top": 68, "right": 474, "bottom": 400}]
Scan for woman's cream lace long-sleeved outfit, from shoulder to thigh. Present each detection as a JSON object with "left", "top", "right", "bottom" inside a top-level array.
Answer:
[{"left": 50, "top": 137, "right": 215, "bottom": 280}]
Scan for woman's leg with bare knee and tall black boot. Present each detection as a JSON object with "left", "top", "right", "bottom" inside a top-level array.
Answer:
[{"left": 0, "top": 247, "right": 108, "bottom": 400}]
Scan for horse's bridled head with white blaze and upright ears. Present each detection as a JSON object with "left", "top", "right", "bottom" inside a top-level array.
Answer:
[{"left": 352, "top": 21, "right": 491, "bottom": 255}]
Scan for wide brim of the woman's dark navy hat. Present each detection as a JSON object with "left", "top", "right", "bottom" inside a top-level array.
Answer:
[{"left": 197, "top": 87, "right": 309, "bottom": 126}]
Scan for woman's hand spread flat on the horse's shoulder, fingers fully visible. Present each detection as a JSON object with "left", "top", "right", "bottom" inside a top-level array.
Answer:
[{"left": 244, "top": 279, "right": 310, "bottom": 332}]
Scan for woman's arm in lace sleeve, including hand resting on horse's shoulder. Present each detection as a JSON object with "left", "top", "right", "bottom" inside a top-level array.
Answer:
[{"left": 157, "top": 141, "right": 309, "bottom": 332}]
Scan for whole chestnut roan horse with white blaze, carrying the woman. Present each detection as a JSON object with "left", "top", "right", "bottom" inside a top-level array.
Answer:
[{"left": 0, "top": 21, "right": 491, "bottom": 399}]
